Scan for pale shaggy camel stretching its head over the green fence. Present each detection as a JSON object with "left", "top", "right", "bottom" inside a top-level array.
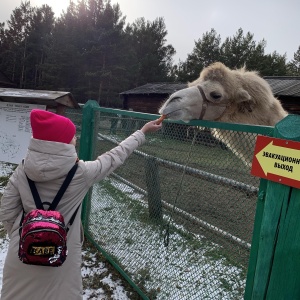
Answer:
[{"left": 159, "top": 62, "right": 288, "bottom": 166}]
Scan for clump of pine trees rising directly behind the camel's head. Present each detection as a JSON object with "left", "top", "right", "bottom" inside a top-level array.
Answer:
[{"left": 174, "top": 28, "right": 287, "bottom": 82}]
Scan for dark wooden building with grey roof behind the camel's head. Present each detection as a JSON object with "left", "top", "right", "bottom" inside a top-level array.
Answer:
[{"left": 120, "top": 76, "right": 300, "bottom": 114}]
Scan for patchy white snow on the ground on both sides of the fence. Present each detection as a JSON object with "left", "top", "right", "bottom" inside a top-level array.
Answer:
[{"left": 0, "top": 163, "right": 245, "bottom": 300}]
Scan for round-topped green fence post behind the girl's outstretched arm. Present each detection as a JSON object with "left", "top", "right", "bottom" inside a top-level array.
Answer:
[{"left": 79, "top": 100, "right": 99, "bottom": 230}]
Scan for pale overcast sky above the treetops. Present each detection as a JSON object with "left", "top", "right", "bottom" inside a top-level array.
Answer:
[{"left": 0, "top": 0, "right": 300, "bottom": 63}]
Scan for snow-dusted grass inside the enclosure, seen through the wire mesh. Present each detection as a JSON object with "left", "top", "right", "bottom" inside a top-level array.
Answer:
[{"left": 90, "top": 179, "right": 245, "bottom": 300}]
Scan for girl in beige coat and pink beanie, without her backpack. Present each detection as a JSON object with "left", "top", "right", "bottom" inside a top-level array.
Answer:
[{"left": 0, "top": 109, "right": 162, "bottom": 300}]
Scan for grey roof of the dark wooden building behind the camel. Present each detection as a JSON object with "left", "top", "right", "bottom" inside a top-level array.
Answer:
[{"left": 120, "top": 76, "right": 300, "bottom": 97}]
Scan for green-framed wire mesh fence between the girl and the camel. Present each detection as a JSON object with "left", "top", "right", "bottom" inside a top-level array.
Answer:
[{"left": 67, "top": 101, "right": 273, "bottom": 300}]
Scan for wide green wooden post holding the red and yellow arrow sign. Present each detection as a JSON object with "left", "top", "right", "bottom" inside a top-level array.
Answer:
[{"left": 246, "top": 115, "right": 300, "bottom": 300}]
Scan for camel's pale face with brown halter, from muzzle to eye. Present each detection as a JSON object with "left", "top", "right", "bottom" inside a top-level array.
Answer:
[{"left": 159, "top": 81, "right": 228, "bottom": 122}]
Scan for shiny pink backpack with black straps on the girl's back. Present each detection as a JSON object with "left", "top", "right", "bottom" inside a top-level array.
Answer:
[{"left": 18, "top": 163, "right": 79, "bottom": 267}]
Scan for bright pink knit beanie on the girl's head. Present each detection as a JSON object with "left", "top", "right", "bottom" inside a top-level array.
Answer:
[{"left": 30, "top": 109, "right": 76, "bottom": 144}]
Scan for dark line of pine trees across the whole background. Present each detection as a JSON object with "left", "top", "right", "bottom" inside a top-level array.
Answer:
[{"left": 0, "top": 0, "right": 300, "bottom": 107}]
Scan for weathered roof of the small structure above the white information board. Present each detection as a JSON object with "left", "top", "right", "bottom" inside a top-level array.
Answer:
[{"left": 0, "top": 88, "right": 79, "bottom": 108}]
